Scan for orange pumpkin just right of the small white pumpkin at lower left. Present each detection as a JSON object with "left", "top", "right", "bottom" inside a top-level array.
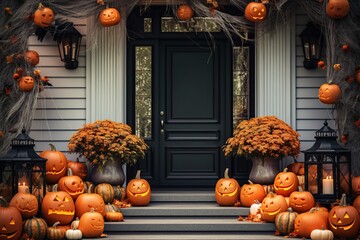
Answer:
[{"left": 78, "top": 209, "right": 105, "bottom": 238}]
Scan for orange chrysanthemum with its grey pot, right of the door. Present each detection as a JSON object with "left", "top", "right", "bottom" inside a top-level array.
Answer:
[{"left": 223, "top": 116, "right": 300, "bottom": 184}]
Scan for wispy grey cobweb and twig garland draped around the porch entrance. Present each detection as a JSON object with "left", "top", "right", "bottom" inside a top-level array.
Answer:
[{"left": 0, "top": 0, "right": 360, "bottom": 175}]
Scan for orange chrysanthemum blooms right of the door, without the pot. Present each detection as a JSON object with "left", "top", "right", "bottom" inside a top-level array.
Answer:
[{"left": 223, "top": 116, "right": 300, "bottom": 159}]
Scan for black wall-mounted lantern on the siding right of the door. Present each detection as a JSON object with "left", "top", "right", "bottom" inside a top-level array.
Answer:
[{"left": 299, "top": 22, "right": 323, "bottom": 69}]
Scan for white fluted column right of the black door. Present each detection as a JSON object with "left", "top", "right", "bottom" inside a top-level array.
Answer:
[{"left": 255, "top": 21, "right": 296, "bottom": 127}]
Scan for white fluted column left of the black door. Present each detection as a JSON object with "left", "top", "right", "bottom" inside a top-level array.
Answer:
[{"left": 86, "top": 17, "right": 126, "bottom": 123}]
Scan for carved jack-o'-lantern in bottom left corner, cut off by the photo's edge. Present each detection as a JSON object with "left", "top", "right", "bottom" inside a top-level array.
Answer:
[{"left": 0, "top": 206, "right": 22, "bottom": 240}]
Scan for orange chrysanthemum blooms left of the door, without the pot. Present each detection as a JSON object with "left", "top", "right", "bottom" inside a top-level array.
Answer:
[{"left": 68, "top": 120, "right": 148, "bottom": 165}]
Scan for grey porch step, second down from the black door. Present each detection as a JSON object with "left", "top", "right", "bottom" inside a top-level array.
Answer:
[{"left": 121, "top": 202, "right": 249, "bottom": 219}]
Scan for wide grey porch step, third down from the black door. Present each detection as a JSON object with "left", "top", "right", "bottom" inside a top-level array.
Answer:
[{"left": 105, "top": 217, "right": 275, "bottom": 233}]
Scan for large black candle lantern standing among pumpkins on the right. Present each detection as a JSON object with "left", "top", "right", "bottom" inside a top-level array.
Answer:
[{"left": 303, "top": 121, "right": 351, "bottom": 204}]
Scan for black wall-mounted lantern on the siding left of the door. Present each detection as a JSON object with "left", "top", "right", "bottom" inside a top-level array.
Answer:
[{"left": 55, "top": 22, "right": 82, "bottom": 69}]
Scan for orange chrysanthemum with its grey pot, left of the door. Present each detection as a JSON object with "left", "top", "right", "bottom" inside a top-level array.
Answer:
[{"left": 68, "top": 120, "right": 148, "bottom": 185}]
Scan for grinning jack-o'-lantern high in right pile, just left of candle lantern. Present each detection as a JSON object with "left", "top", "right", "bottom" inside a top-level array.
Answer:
[{"left": 274, "top": 168, "right": 299, "bottom": 197}]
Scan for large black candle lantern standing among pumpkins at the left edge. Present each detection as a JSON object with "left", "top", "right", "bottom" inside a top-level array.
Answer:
[{"left": 0, "top": 129, "right": 46, "bottom": 203}]
